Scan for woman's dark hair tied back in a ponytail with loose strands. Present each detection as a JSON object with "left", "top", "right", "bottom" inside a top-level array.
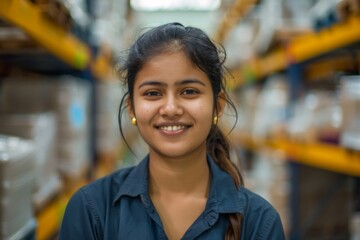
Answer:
[{"left": 118, "top": 23, "right": 243, "bottom": 240}]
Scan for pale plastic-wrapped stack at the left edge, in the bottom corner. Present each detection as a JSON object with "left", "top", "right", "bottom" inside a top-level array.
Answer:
[{"left": 0, "top": 135, "right": 35, "bottom": 239}]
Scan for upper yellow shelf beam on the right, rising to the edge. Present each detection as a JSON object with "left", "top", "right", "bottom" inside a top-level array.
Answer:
[{"left": 231, "top": 17, "right": 360, "bottom": 88}]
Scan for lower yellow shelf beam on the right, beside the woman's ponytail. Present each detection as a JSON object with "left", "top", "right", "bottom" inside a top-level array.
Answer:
[{"left": 236, "top": 135, "right": 360, "bottom": 177}]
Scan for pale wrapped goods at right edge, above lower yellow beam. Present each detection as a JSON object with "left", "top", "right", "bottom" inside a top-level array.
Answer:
[{"left": 340, "top": 76, "right": 360, "bottom": 150}]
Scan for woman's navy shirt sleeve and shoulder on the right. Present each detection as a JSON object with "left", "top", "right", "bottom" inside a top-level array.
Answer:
[{"left": 238, "top": 188, "right": 285, "bottom": 239}]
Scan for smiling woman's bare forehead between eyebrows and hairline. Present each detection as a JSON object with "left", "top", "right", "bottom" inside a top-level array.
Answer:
[{"left": 135, "top": 51, "right": 210, "bottom": 85}]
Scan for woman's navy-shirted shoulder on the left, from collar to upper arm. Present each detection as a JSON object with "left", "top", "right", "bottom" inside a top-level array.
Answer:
[{"left": 60, "top": 167, "right": 138, "bottom": 240}]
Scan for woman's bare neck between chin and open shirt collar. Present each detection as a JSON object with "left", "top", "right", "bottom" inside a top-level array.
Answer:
[{"left": 149, "top": 149, "right": 210, "bottom": 197}]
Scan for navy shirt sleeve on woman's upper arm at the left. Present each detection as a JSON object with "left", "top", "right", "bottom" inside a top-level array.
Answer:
[{"left": 59, "top": 189, "right": 103, "bottom": 240}]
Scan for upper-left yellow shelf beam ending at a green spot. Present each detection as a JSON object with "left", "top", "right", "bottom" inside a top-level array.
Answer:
[{"left": 0, "top": 0, "right": 91, "bottom": 70}]
